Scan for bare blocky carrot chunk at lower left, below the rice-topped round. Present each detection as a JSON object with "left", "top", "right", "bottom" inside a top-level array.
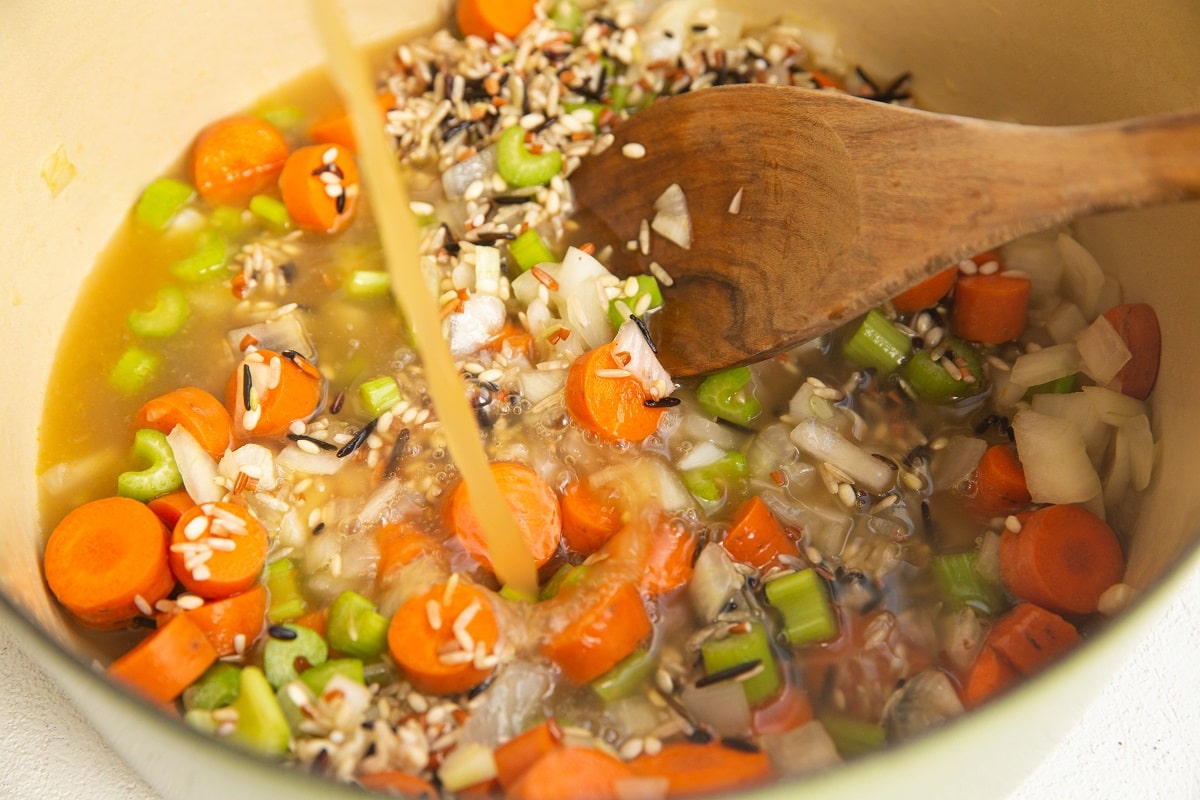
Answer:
[{"left": 108, "top": 614, "right": 217, "bottom": 703}]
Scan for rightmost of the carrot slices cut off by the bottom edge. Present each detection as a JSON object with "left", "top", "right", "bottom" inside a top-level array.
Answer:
[{"left": 629, "top": 741, "right": 774, "bottom": 798}]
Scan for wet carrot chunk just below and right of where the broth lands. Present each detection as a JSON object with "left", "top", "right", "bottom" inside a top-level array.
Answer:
[{"left": 541, "top": 581, "right": 652, "bottom": 684}]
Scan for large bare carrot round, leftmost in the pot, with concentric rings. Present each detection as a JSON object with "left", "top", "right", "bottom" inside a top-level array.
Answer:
[{"left": 43, "top": 498, "right": 175, "bottom": 628}]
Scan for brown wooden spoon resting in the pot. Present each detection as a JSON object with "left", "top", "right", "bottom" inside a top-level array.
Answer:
[{"left": 571, "top": 85, "right": 1200, "bottom": 377}]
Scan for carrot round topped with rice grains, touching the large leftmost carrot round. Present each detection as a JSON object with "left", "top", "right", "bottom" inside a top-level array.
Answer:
[{"left": 170, "top": 503, "right": 268, "bottom": 600}]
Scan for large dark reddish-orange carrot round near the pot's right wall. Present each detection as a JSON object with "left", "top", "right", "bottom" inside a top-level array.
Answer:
[{"left": 1000, "top": 505, "right": 1124, "bottom": 614}]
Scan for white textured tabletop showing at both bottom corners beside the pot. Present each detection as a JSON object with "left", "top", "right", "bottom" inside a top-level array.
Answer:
[{"left": 0, "top": 572, "right": 1200, "bottom": 800}]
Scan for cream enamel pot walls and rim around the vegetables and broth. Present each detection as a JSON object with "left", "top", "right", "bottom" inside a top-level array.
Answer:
[{"left": 0, "top": 0, "right": 1200, "bottom": 799}]
